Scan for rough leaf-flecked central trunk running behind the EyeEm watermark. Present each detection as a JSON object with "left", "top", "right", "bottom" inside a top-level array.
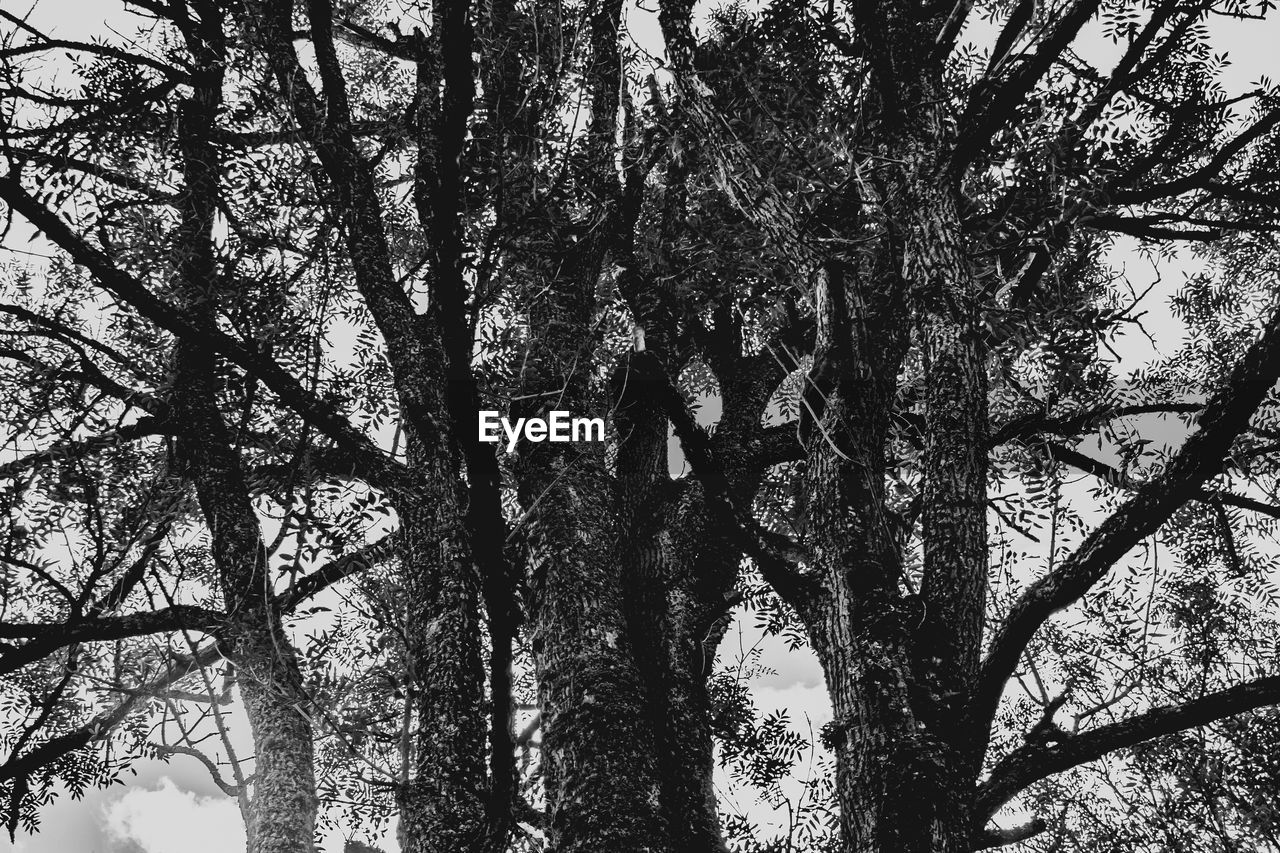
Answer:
[{"left": 516, "top": 227, "right": 666, "bottom": 853}]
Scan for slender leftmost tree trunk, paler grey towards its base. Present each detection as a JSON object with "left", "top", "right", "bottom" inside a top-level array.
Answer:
[{"left": 173, "top": 3, "right": 317, "bottom": 853}]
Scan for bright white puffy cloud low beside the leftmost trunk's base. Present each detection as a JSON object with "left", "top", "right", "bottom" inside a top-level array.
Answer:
[{"left": 102, "top": 779, "right": 244, "bottom": 853}]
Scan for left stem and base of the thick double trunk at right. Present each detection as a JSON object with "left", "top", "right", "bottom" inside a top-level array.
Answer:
[{"left": 803, "top": 253, "right": 972, "bottom": 853}]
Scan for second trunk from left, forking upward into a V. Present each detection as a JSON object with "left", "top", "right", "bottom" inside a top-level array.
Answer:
[{"left": 240, "top": 0, "right": 494, "bottom": 853}]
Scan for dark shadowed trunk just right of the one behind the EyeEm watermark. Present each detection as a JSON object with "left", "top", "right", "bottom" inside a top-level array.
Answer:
[{"left": 614, "top": 353, "right": 739, "bottom": 853}]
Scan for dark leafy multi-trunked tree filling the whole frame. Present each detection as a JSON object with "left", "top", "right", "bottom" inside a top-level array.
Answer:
[{"left": 0, "top": 0, "right": 1280, "bottom": 852}]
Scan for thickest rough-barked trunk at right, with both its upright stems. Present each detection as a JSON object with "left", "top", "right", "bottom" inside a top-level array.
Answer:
[{"left": 762, "top": 4, "right": 987, "bottom": 835}]
